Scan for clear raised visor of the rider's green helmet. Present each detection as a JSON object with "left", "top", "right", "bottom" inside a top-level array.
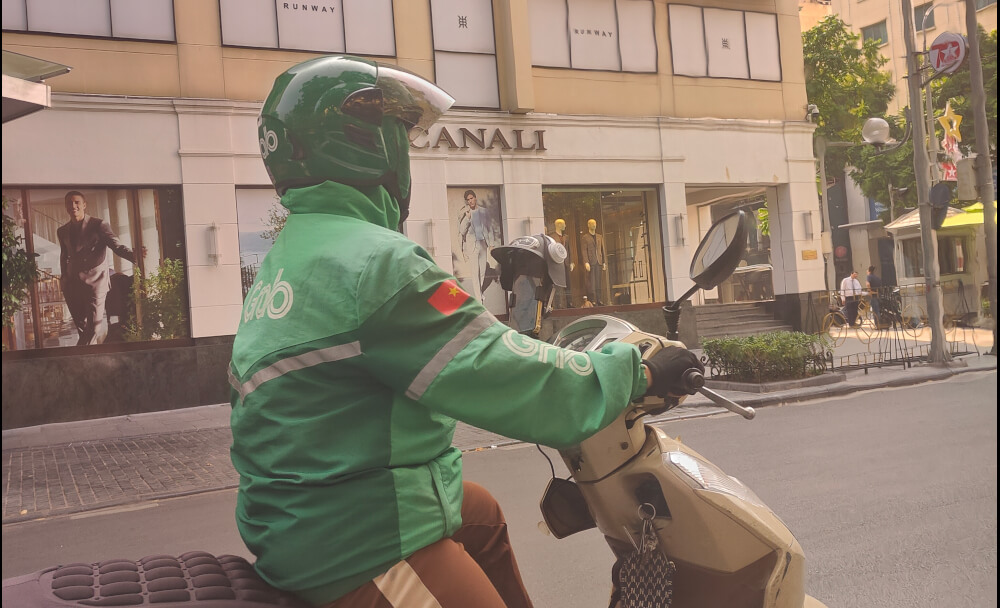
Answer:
[{"left": 375, "top": 63, "right": 455, "bottom": 131}]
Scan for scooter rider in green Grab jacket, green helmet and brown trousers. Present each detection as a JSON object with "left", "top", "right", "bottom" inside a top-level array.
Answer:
[{"left": 229, "top": 56, "right": 701, "bottom": 608}]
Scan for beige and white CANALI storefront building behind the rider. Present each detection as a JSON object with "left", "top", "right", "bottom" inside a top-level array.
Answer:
[{"left": 3, "top": 0, "right": 824, "bottom": 428}]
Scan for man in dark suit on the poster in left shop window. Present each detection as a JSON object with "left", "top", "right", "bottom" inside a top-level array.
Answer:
[{"left": 56, "top": 190, "right": 135, "bottom": 346}]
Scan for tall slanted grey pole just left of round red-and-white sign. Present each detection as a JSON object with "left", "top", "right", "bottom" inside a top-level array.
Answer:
[{"left": 903, "top": 0, "right": 951, "bottom": 363}]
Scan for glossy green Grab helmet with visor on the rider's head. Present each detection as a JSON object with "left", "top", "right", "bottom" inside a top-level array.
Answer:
[{"left": 257, "top": 55, "right": 455, "bottom": 215}]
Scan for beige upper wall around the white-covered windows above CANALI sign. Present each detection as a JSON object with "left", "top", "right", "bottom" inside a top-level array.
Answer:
[{"left": 3, "top": 0, "right": 806, "bottom": 121}]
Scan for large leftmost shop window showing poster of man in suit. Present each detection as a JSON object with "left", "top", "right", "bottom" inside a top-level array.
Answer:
[{"left": 3, "top": 187, "right": 190, "bottom": 350}]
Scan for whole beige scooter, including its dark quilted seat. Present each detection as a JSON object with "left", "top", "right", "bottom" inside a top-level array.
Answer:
[{"left": 3, "top": 211, "right": 824, "bottom": 608}]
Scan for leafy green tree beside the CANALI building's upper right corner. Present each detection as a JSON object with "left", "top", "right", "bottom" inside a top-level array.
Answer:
[{"left": 802, "top": 15, "right": 894, "bottom": 175}]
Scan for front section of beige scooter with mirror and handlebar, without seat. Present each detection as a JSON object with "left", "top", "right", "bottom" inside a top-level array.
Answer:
[{"left": 500, "top": 211, "right": 823, "bottom": 608}]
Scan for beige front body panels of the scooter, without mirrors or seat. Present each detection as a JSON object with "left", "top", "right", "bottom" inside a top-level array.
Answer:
[{"left": 543, "top": 316, "right": 823, "bottom": 608}]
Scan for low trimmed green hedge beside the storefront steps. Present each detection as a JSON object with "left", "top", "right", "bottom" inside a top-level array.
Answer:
[{"left": 702, "top": 331, "right": 824, "bottom": 383}]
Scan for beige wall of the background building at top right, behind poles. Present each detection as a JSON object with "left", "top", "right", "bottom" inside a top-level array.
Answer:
[{"left": 833, "top": 0, "right": 997, "bottom": 112}]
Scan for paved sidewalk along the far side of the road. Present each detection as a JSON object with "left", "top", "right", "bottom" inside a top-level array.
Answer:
[{"left": 3, "top": 338, "right": 996, "bottom": 524}]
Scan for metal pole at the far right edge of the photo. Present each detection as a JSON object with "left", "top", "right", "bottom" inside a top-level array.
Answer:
[{"left": 965, "top": 0, "right": 997, "bottom": 356}]
